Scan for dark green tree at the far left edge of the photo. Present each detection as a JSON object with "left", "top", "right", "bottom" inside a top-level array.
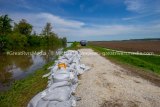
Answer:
[{"left": 0, "top": 15, "right": 12, "bottom": 35}]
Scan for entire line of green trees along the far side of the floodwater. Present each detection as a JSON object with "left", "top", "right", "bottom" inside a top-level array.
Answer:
[{"left": 0, "top": 15, "right": 67, "bottom": 52}]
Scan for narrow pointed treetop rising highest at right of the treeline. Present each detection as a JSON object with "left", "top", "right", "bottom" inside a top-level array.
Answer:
[{"left": 42, "top": 22, "right": 52, "bottom": 36}]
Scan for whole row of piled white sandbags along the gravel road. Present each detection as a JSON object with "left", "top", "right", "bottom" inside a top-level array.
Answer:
[{"left": 28, "top": 50, "right": 89, "bottom": 107}]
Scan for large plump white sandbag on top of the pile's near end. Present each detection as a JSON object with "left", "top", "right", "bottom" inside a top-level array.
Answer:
[{"left": 42, "top": 86, "right": 71, "bottom": 102}]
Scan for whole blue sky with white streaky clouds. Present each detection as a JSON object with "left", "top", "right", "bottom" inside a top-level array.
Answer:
[{"left": 0, "top": 0, "right": 160, "bottom": 41}]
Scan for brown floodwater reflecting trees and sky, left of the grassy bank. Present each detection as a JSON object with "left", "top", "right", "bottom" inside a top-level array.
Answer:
[{"left": 0, "top": 48, "right": 62, "bottom": 91}]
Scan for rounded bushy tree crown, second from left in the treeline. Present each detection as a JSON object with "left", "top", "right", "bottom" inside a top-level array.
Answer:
[{"left": 14, "top": 19, "right": 32, "bottom": 35}]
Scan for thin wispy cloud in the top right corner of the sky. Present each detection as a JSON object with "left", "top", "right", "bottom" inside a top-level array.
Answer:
[{"left": 122, "top": 0, "right": 160, "bottom": 20}]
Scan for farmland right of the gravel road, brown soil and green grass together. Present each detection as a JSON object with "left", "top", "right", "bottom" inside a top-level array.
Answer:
[{"left": 89, "top": 40, "right": 160, "bottom": 75}]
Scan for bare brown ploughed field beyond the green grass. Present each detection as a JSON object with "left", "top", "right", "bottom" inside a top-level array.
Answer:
[{"left": 90, "top": 40, "right": 160, "bottom": 54}]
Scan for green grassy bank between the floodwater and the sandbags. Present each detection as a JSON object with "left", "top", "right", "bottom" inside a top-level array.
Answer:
[{"left": 0, "top": 61, "right": 54, "bottom": 107}]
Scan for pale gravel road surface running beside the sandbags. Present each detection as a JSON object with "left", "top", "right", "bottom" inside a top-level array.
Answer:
[{"left": 76, "top": 49, "right": 160, "bottom": 107}]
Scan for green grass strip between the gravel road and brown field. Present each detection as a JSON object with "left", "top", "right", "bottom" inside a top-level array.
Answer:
[{"left": 90, "top": 46, "right": 160, "bottom": 75}]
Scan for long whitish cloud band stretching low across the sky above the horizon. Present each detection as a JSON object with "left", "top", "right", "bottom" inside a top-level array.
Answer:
[{"left": 10, "top": 13, "right": 160, "bottom": 40}]
